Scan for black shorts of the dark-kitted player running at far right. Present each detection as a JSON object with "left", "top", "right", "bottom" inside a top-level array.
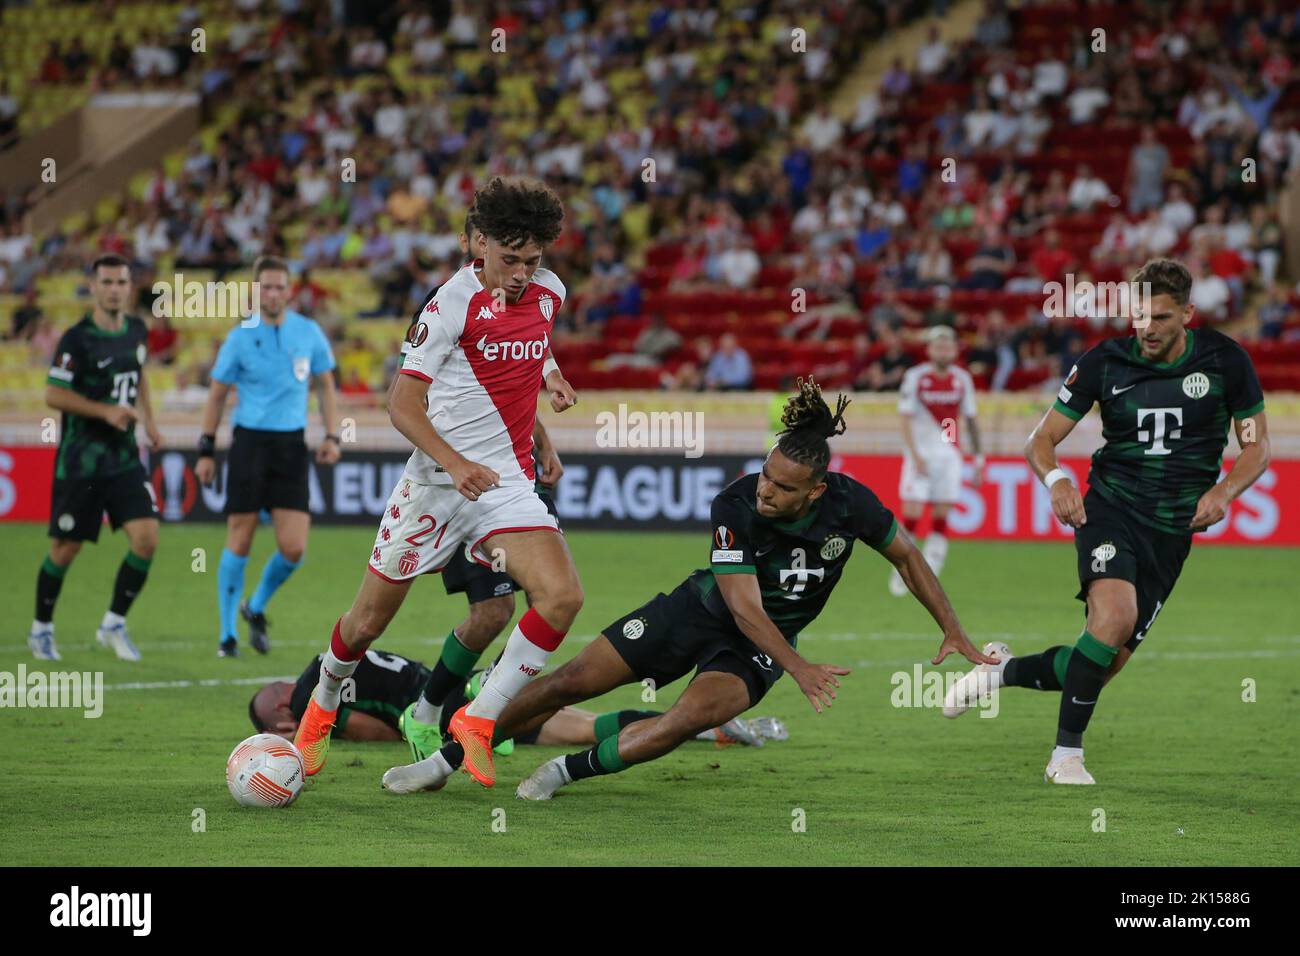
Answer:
[{"left": 1074, "top": 488, "right": 1192, "bottom": 652}]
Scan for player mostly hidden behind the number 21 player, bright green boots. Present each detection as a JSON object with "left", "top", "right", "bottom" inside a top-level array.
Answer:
[{"left": 392, "top": 216, "right": 564, "bottom": 760}]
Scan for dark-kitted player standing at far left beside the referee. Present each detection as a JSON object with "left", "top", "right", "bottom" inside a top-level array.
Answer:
[{"left": 27, "top": 255, "right": 163, "bottom": 661}]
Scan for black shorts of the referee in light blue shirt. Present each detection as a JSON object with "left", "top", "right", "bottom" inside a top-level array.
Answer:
[{"left": 226, "top": 425, "right": 308, "bottom": 515}]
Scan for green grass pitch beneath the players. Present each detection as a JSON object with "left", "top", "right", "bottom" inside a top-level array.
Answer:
[{"left": 0, "top": 525, "right": 1300, "bottom": 865}]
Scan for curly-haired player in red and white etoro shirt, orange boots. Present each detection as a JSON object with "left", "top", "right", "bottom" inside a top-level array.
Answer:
[{"left": 295, "top": 177, "right": 582, "bottom": 786}]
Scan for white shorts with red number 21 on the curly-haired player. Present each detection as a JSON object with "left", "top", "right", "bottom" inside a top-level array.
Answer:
[{"left": 371, "top": 475, "right": 559, "bottom": 583}]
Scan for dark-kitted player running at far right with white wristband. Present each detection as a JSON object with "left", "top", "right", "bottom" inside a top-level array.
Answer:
[{"left": 944, "top": 259, "right": 1269, "bottom": 784}]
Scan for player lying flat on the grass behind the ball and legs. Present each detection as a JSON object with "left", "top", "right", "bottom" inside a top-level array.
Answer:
[{"left": 248, "top": 648, "right": 789, "bottom": 753}]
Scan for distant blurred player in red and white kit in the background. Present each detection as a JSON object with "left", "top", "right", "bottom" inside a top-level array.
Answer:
[{"left": 889, "top": 325, "right": 984, "bottom": 597}]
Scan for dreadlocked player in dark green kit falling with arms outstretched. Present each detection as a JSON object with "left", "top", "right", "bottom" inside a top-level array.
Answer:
[{"left": 384, "top": 378, "right": 993, "bottom": 800}]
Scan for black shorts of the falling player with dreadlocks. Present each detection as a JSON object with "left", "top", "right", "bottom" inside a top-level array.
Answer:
[{"left": 602, "top": 581, "right": 784, "bottom": 706}]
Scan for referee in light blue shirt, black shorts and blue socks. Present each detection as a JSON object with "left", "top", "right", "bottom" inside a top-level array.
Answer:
[{"left": 194, "top": 256, "right": 339, "bottom": 657}]
